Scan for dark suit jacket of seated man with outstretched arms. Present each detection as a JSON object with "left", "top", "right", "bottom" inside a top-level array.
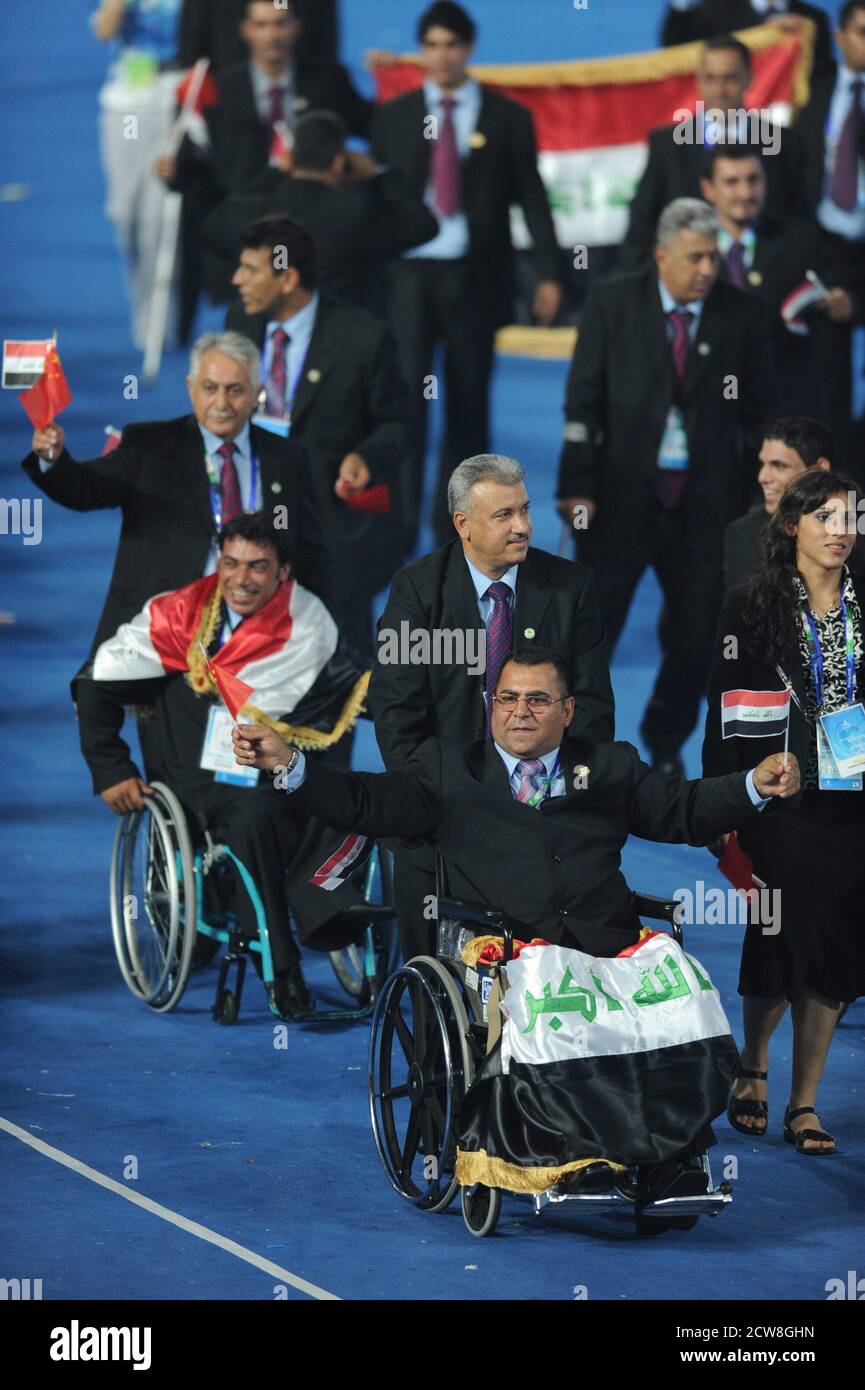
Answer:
[{"left": 280, "top": 738, "right": 759, "bottom": 956}]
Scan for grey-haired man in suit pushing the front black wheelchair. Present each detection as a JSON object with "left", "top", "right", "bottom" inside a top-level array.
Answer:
[{"left": 369, "top": 455, "right": 615, "bottom": 959}]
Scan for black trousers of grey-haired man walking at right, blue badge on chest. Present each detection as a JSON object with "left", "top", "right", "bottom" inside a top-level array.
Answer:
[{"left": 579, "top": 502, "right": 723, "bottom": 756}]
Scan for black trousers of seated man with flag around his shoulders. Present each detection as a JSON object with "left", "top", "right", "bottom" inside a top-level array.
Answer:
[{"left": 171, "top": 771, "right": 303, "bottom": 973}]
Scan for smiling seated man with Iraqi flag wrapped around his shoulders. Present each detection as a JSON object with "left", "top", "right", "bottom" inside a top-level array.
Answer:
[{"left": 72, "top": 513, "right": 369, "bottom": 1019}]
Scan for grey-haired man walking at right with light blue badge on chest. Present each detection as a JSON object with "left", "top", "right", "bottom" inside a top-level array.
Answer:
[{"left": 558, "top": 199, "right": 772, "bottom": 773}]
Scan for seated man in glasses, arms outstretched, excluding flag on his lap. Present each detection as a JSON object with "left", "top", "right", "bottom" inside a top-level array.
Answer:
[{"left": 232, "top": 648, "right": 798, "bottom": 1182}]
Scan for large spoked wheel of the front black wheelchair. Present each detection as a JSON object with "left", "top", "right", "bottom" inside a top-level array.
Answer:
[{"left": 369, "top": 956, "right": 474, "bottom": 1212}]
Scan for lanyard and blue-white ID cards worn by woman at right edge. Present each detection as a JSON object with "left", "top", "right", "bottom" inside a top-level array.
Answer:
[{"left": 800, "top": 581, "right": 865, "bottom": 791}]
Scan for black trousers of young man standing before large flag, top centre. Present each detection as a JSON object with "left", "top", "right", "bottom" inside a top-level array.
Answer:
[{"left": 388, "top": 259, "right": 495, "bottom": 553}]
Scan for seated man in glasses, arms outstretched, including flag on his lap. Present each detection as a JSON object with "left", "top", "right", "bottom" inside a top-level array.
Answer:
[{"left": 232, "top": 648, "right": 798, "bottom": 1201}]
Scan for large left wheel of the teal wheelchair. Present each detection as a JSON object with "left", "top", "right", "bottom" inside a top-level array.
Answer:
[{"left": 110, "top": 783, "right": 196, "bottom": 1013}]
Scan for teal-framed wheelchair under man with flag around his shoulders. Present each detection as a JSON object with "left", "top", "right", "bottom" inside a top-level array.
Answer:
[{"left": 110, "top": 781, "right": 399, "bottom": 1024}]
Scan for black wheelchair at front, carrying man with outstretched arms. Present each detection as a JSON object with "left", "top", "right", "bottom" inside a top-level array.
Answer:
[{"left": 369, "top": 856, "right": 733, "bottom": 1237}]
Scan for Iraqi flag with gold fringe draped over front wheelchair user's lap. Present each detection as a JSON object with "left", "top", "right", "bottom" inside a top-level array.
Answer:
[{"left": 456, "top": 929, "right": 738, "bottom": 1193}]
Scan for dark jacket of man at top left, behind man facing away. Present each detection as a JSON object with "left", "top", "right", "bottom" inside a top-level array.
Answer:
[{"left": 172, "top": 63, "right": 371, "bottom": 199}]
